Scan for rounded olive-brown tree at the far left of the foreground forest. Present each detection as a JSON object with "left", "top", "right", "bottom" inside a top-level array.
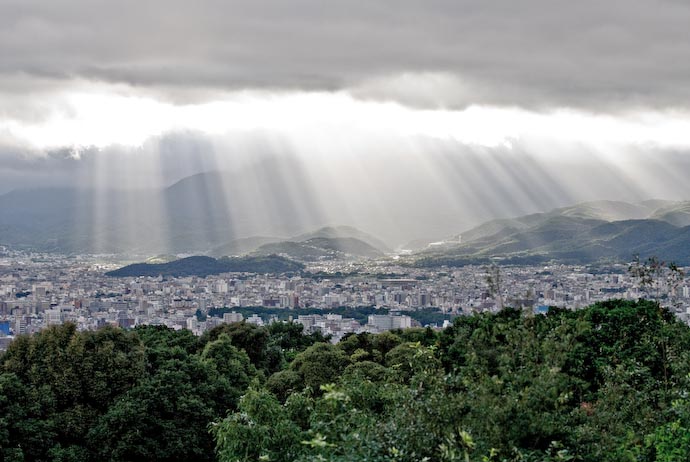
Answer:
[{"left": 2, "top": 323, "right": 145, "bottom": 460}]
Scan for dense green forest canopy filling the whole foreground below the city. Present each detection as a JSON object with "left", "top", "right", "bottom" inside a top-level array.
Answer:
[{"left": 0, "top": 300, "right": 690, "bottom": 462}]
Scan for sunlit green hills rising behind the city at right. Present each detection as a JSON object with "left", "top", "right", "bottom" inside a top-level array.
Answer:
[{"left": 416, "top": 201, "right": 690, "bottom": 266}]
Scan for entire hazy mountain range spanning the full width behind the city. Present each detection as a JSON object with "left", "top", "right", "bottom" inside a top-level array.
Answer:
[{"left": 0, "top": 172, "right": 690, "bottom": 265}]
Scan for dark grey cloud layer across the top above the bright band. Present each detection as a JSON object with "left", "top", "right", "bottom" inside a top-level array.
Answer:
[{"left": 0, "top": 0, "right": 690, "bottom": 111}]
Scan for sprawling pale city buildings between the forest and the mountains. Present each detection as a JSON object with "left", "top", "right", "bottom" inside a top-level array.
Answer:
[{"left": 0, "top": 245, "right": 690, "bottom": 348}]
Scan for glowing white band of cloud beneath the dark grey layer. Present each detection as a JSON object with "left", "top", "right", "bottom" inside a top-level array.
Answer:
[{"left": 0, "top": 86, "right": 690, "bottom": 153}]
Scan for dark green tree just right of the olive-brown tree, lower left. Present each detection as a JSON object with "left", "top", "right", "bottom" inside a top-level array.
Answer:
[{"left": 88, "top": 355, "right": 226, "bottom": 462}]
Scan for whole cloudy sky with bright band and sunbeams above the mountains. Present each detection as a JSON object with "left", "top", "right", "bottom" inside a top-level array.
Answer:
[{"left": 0, "top": 0, "right": 690, "bottom": 245}]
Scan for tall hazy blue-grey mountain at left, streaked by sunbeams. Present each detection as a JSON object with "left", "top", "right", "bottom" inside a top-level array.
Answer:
[{"left": 0, "top": 170, "right": 388, "bottom": 256}]
